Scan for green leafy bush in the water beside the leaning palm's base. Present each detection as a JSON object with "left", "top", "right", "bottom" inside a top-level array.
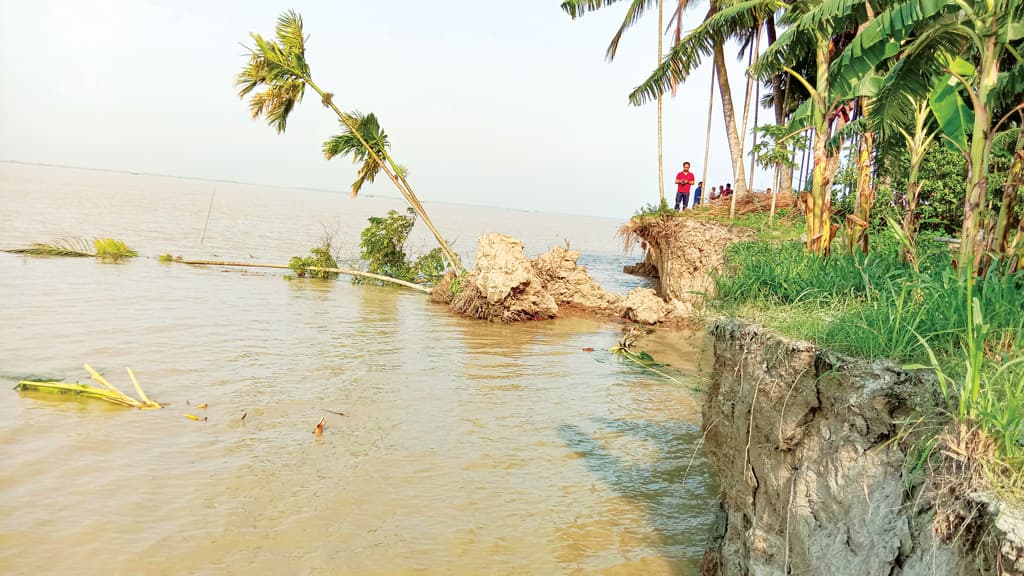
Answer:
[{"left": 352, "top": 208, "right": 446, "bottom": 284}]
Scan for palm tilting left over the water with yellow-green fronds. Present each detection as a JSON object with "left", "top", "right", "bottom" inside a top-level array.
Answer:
[{"left": 234, "top": 10, "right": 464, "bottom": 272}]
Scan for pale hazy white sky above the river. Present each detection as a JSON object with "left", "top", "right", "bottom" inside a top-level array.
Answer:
[{"left": 0, "top": 0, "right": 770, "bottom": 217}]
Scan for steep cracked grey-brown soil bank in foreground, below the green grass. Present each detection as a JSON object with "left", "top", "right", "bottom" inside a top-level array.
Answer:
[{"left": 702, "top": 320, "right": 1024, "bottom": 576}]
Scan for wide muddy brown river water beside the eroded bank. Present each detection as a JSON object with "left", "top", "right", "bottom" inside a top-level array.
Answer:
[{"left": 0, "top": 165, "right": 715, "bottom": 574}]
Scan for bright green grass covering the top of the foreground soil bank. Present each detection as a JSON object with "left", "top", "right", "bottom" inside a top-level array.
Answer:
[{"left": 713, "top": 237, "right": 1024, "bottom": 497}]
